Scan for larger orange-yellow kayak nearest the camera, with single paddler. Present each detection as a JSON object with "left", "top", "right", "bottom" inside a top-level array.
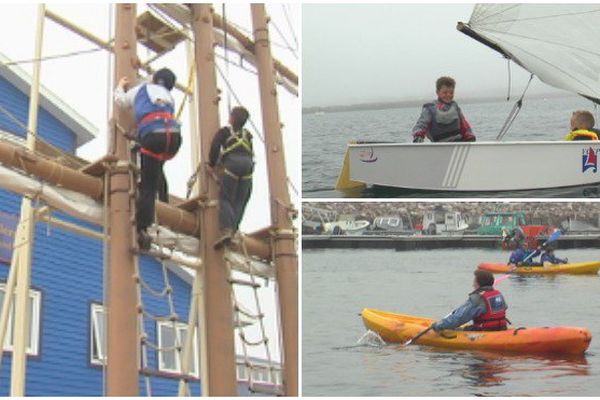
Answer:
[{"left": 361, "top": 308, "right": 592, "bottom": 354}]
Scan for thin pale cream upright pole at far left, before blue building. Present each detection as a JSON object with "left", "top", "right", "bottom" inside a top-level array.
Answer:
[{"left": 10, "top": 4, "right": 45, "bottom": 396}]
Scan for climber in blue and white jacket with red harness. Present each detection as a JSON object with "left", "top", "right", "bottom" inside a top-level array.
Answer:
[{"left": 114, "top": 68, "right": 181, "bottom": 250}]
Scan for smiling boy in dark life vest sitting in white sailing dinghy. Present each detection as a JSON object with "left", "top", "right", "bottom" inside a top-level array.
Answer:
[{"left": 412, "top": 76, "right": 475, "bottom": 143}]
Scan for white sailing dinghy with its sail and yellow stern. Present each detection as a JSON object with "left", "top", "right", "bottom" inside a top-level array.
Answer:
[{"left": 336, "top": 4, "right": 600, "bottom": 192}]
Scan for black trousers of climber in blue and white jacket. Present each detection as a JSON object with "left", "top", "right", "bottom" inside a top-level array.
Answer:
[{"left": 136, "top": 132, "right": 181, "bottom": 230}]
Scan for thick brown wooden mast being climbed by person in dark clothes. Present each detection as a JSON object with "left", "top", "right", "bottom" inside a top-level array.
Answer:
[{"left": 191, "top": 4, "right": 237, "bottom": 396}]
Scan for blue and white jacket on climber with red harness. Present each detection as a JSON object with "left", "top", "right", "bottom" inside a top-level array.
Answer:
[{"left": 133, "top": 83, "right": 181, "bottom": 139}]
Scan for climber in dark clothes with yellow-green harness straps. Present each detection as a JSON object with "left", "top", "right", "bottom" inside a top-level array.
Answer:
[{"left": 209, "top": 107, "right": 254, "bottom": 249}]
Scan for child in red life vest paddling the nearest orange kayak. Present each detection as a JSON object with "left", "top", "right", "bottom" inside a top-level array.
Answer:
[{"left": 432, "top": 270, "right": 508, "bottom": 332}]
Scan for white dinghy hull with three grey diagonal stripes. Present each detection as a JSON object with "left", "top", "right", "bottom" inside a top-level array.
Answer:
[{"left": 348, "top": 141, "right": 600, "bottom": 192}]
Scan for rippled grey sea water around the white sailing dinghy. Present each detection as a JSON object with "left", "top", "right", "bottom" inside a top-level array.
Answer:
[{"left": 302, "top": 97, "right": 600, "bottom": 198}]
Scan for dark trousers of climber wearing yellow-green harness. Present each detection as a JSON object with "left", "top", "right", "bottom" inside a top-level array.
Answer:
[{"left": 219, "top": 152, "right": 254, "bottom": 232}]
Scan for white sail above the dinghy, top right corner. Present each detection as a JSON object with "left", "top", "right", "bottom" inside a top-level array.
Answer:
[{"left": 467, "top": 3, "right": 600, "bottom": 102}]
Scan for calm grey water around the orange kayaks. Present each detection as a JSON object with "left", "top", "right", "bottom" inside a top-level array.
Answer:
[{"left": 302, "top": 249, "right": 600, "bottom": 396}]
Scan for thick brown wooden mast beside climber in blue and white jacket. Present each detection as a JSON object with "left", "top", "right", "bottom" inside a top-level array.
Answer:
[{"left": 106, "top": 4, "right": 140, "bottom": 396}]
